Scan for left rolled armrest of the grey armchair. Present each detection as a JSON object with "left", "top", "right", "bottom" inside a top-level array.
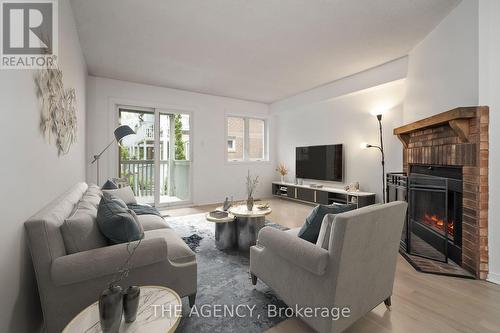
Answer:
[{"left": 257, "top": 227, "right": 329, "bottom": 275}]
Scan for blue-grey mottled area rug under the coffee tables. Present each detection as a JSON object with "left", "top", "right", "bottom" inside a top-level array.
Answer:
[{"left": 165, "top": 214, "right": 286, "bottom": 333}]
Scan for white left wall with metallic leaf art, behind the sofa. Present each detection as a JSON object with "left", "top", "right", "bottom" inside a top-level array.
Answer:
[{"left": 0, "top": 0, "right": 87, "bottom": 333}]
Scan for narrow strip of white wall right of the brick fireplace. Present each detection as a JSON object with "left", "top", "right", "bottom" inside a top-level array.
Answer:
[{"left": 479, "top": 0, "right": 500, "bottom": 284}]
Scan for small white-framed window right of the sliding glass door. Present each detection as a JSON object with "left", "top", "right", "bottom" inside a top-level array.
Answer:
[{"left": 226, "top": 116, "right": 267, "bottom": 162}]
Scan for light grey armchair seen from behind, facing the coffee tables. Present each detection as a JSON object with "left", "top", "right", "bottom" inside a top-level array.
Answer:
[{"left": 250, "top": 202, "right": 407, "bottom": 333}]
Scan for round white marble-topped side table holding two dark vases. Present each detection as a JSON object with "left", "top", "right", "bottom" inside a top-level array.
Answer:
[{"left": 63, "top": 286, "right": 182, "bottom": 333}]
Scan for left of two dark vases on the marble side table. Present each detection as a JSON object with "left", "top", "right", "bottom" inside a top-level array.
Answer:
[{"left": 99, "top": 286, "right": 123, "bottom": 333}]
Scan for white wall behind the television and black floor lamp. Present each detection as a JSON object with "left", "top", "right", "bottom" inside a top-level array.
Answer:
[{"left": 275, "top": 80, "right": 405, "bottom": 201}]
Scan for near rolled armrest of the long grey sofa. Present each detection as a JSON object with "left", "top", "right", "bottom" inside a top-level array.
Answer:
[{"left": 52, "top": 237, "right": 167, "bottom": 286}]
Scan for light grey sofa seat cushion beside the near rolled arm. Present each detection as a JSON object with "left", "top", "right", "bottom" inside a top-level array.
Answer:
[{"left": 144, "top": 228, "right": 196, "bottom": 264}]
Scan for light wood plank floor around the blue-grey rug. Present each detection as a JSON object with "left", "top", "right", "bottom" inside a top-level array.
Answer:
[{"left": 167, "top": 198, "right": 500, "bottom": 333}]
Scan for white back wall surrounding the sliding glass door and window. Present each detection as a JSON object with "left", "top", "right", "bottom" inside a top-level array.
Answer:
[{"left": 87, "top": 77, "right": 275, "bottom": 205}]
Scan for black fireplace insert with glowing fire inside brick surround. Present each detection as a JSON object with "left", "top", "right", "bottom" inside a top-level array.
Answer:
[{"left": 387, "top": 164, "right": 463, "bottom": 265}]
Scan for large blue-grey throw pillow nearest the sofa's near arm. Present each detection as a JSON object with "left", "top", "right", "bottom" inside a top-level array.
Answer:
[{"left": 97, "top": 193, "right": 144, "bottom": 244}]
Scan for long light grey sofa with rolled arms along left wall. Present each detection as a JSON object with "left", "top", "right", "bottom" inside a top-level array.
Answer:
[{"left": 25, "top": 183, "right": 197, "bottom": 333}]
